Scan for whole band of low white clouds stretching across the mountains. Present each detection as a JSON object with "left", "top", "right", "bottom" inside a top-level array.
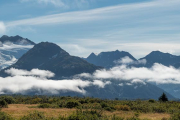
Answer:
[{"left": 0, "top": 63, "right": 180, "bottom": 94}]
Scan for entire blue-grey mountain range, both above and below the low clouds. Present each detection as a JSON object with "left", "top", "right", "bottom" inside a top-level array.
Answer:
[{"left": 0, "top": 36, "right": 180, "bottom": 99}]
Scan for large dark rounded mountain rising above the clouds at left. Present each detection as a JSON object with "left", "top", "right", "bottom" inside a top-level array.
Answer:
[{"left": 1, "top": 42, "right": 101, "bottom": 77}]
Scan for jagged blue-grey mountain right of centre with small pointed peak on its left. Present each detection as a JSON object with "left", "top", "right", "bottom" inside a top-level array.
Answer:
[{"left": 85, "top": 50, "right": 137, "bottom": 68}]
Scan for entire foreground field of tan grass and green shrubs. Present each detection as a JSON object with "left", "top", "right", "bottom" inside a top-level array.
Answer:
[{"left": 0, "top": 96, "right": 180, "bottom": 120}]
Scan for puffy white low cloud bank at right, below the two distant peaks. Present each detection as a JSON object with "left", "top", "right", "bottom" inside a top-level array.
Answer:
[{"left": 78, "top": 63, "right": 180, "bottom": 84}]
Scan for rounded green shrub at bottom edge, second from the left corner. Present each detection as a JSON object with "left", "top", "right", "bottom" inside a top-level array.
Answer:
[{"left": 20, "top": 111, "right": 47, "bottom": 120}]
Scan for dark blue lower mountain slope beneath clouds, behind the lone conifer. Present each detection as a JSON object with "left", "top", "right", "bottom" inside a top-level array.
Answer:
[{"left": 85, "top": 81, "right": 175, "bottom": 100}]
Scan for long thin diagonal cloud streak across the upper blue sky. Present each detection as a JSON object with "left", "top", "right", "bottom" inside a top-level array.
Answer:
[{"left": 7, "top": 0, "right": 180, "bottom": 26}]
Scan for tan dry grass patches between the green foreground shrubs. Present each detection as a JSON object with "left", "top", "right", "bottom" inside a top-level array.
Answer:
[{"left": 2, "top": 104, "right": 170, "bottom": 120}]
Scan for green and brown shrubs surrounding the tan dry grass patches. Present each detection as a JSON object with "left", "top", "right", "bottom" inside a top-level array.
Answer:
[{"left": 0, "top": 96, "right": 180, "bottom": 120}]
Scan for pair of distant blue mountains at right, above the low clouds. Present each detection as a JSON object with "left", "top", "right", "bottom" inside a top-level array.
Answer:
[{"left": 84, "top": 50, "right": 180, "bottom": 69}]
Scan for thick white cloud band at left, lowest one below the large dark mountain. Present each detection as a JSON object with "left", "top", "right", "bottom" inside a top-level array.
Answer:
[{"left": 0, "top": 76, "right": 90, "bottom": 94}]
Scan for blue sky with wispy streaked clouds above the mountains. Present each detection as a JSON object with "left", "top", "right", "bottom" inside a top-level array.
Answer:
[{"left": 0, "top": 0, "right": 180, "bottom": 58}]
